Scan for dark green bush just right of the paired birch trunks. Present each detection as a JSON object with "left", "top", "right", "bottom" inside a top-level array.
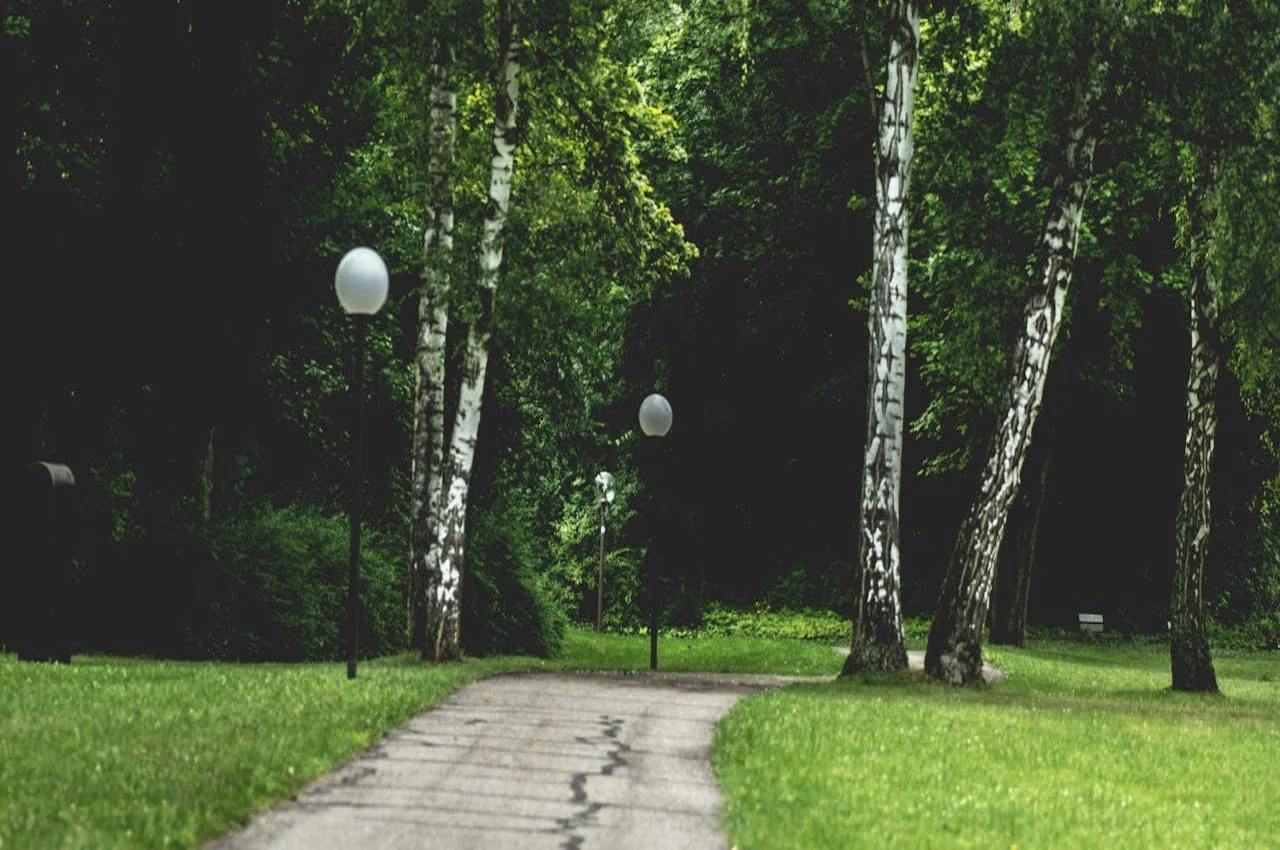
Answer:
[{"left": 462, "top": 507, "right": 568, "bottom": 658}]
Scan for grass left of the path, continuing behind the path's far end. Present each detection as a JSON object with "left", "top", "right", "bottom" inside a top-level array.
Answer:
[{"left": 0, "top": 630, "right": 840, "bottom": 850}]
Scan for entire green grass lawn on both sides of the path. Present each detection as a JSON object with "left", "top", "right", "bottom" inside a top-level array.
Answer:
[{"left": 0, "top": 630, "right": 1280, "bottom": 850}]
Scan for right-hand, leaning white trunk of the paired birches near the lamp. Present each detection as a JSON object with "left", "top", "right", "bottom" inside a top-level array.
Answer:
[{"left": 428, "top": 0, "right": 521, "bottom": 661}]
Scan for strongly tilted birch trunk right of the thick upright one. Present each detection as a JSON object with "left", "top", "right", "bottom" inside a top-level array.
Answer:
[{"left": 924, "top": 63, "right": 1105, "bottom": 685}]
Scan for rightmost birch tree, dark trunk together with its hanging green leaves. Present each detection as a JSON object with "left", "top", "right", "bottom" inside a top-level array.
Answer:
[{"left": 1165, "top": 0, "right": 1277, "bottom": 693}]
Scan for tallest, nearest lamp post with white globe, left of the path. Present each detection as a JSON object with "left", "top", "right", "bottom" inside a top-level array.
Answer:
[{"left": 334, "top": 247, "right": 387, "bottom": 678}]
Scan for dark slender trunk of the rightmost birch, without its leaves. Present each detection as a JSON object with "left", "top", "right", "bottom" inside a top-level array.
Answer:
[{"left": 1169, "top": 172, "right": 1220, "bottom": 693}]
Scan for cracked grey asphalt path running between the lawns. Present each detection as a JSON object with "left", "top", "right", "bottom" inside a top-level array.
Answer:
[{"left": 207, "top": 673, "right": 796, "bottom": 850}]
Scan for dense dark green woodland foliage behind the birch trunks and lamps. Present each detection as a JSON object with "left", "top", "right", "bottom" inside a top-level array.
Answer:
[{"left": 0, "top": 0, "right": 1280, "bottom": 658}]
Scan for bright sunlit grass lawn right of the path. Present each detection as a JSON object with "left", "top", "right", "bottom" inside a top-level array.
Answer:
[{"left": 713, "top": 644, "right": 1280, "bottom": 850}]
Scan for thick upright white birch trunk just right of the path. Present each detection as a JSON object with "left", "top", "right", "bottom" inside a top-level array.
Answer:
[{"left": 842, "top": 0, "right": 920, "bottom": 675}]
